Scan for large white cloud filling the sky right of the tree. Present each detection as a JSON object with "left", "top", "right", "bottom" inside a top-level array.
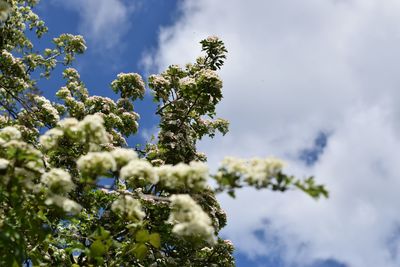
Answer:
[{"left": 145, "top": 0, "right": 400, "bottom": 267}]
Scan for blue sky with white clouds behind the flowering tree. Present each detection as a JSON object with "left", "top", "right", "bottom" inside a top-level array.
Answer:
[{"left": 32, "top": 0, "right": 400, "bottom": 267}]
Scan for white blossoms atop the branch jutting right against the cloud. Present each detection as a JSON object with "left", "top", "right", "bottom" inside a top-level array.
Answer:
[{"left": 217, "top": 157, "right": 284, "bottom": 187}]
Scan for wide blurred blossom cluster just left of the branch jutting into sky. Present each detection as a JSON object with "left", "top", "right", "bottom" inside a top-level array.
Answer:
[{"left": 156, "top": 161, "right": 209, "bottom": 190}]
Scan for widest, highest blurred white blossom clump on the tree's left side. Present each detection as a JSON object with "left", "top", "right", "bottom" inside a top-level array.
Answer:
[{"left": 39, "top": 114, "right": 109, "bottom": 151}]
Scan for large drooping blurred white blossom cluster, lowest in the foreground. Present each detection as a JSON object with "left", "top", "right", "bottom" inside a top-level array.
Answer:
[{"left": 168, "top": 195, "right": 215, "bottom": 244}]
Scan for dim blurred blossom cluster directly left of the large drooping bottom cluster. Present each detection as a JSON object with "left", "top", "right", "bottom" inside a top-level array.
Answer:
[{"left": 111, "top": 195, "right": 146, "bottom": 221}]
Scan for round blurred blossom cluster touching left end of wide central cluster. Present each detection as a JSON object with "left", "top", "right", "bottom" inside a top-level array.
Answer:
[{"left": 120, "top": 160, "right": 158, "bottom": 184}]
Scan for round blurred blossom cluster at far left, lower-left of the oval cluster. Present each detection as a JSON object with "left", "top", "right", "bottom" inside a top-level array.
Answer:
[{"left": 40, "top": 168, "right": 75, "bottom": 193}]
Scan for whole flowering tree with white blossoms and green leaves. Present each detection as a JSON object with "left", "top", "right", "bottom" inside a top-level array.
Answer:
[{"left": 0, "top": 0, "right": 327, "bottom": 266}]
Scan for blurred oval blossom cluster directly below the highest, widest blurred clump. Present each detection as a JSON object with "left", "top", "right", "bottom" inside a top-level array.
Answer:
[{"left": 76, "top": 152, "right": 117, "bottom": 176}]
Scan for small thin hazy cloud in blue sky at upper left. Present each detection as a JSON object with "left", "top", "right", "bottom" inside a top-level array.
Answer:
[{"left": 53, "top": 0, "right": 135, "bottom": 52}]
